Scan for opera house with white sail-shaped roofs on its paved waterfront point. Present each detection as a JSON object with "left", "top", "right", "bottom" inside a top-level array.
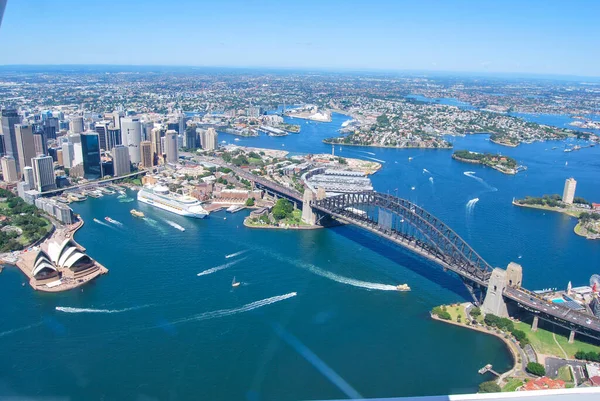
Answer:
[{"left": 17, "top": 221, "right": 108, "bottom": 292}]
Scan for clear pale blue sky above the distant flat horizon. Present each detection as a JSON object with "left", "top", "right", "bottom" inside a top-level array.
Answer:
[{"left": 0, "top": 0, "right": 600, "bottom": 77}]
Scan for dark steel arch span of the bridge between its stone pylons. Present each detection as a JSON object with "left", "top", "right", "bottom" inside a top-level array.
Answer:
[{"left": 312, "top": 191, "right": 493, "bottom": 286}]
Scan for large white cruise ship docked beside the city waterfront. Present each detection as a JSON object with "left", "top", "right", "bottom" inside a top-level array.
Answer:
[{"left": 138, "top": 185, "right": 208, "bottom": 219}]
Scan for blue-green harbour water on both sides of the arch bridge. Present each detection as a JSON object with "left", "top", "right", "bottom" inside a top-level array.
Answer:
[{"left": 0, "top": 114, "right": 600, "bottom": 400}]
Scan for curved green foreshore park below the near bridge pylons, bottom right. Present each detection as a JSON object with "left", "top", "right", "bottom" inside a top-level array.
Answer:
[{"left": 431, "top": 302, "right": 600, "bottom": 393}]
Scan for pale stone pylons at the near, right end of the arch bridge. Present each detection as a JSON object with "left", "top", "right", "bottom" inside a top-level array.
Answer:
[{"left": 482, "top": 262, "right": 523, "bottom": 317}]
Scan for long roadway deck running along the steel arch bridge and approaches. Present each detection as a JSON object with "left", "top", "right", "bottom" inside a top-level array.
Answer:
[{"left": 202, "top": 165, "right": 600, "bottom": 340}]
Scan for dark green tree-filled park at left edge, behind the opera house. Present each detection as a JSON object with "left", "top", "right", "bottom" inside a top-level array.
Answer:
[{"left": 0, "top": 188, "right": 52, "bottom": 252}]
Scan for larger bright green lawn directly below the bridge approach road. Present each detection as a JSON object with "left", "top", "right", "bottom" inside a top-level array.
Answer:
[{"left": 515, "top": 322, "right": 600, "bottom": 358}]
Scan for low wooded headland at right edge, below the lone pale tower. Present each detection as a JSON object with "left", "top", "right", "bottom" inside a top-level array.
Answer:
[{"left": 513, "top": 194, "right": 600, "bottom": 239}]
